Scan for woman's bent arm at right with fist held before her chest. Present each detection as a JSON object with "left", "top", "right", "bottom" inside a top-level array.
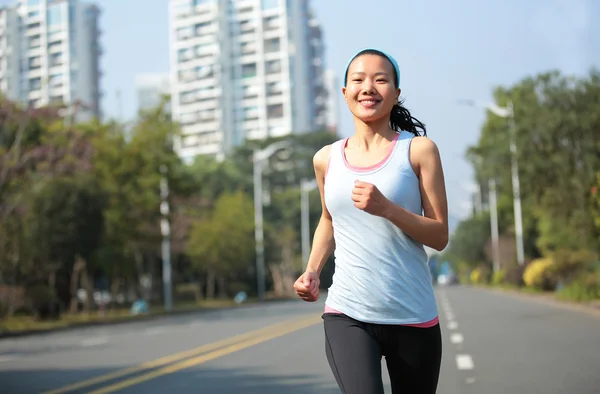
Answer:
[{"left": 352, "top": 137, "right": 448, "bottom": 251}]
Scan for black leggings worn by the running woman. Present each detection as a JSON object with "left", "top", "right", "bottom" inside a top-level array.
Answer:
[{"left": 323, "top": 313, "right": 442, "bottom": 394}]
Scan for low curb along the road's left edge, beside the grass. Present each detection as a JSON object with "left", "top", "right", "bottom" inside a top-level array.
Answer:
[{"left": 0, "top": 298, "right": 292, "bottom": 341}]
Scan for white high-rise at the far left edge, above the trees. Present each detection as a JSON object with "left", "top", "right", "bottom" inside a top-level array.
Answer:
[{"left": 0, "top": 0, "right": 102, "bottom": 120}]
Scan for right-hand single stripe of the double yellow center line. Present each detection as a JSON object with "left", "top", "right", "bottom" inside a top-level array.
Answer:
[{"left": 88, "top": 314, "right": 321, "bottom": 394}]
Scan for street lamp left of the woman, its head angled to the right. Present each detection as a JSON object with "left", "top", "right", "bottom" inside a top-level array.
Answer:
[{"left": 252, "top": 141, "right": 291, "bottom": 301}]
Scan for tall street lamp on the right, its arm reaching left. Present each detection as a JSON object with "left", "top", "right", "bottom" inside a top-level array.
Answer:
[{"left": 459, "top": 100, "right": 525, "bottom": 265}]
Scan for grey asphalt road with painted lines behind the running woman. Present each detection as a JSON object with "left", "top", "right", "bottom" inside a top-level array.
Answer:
[{"left": 0, "top": 287, "right": 600, "bottom": 394}]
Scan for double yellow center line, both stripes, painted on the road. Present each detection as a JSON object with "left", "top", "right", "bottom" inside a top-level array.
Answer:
[{"left": 42, "top": 314, "right": 321, "bottom": 394}]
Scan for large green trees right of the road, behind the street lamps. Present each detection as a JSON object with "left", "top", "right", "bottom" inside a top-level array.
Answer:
[{"left": 468, "top": 70, "right": 600, "bottom": 257}]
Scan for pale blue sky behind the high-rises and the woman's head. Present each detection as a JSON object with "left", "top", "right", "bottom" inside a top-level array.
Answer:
[{"left": 0, "top": 0, "right": 600, "bottom": 222}]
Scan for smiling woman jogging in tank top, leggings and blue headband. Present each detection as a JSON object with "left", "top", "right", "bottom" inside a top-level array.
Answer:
[{"left": 294, "top": 49, "right": 448, "bottom": 394}]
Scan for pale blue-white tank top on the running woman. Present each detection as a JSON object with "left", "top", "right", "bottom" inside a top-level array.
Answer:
[{"left": 324, "top": 131, "right": 438, "bottom": 324}]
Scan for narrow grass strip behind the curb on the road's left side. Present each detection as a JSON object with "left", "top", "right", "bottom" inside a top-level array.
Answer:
[{"left": 0, "top": 299, "right": 255, "bottom": 333}]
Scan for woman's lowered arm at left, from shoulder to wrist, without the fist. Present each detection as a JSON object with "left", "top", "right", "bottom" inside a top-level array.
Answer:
[{"left": 306, "top": 145, "right": 335, "bottom": 275}]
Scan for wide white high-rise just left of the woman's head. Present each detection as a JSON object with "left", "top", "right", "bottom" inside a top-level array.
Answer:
[{"left": 169, "top": 0, "right": 327, "bottom": 159}]
